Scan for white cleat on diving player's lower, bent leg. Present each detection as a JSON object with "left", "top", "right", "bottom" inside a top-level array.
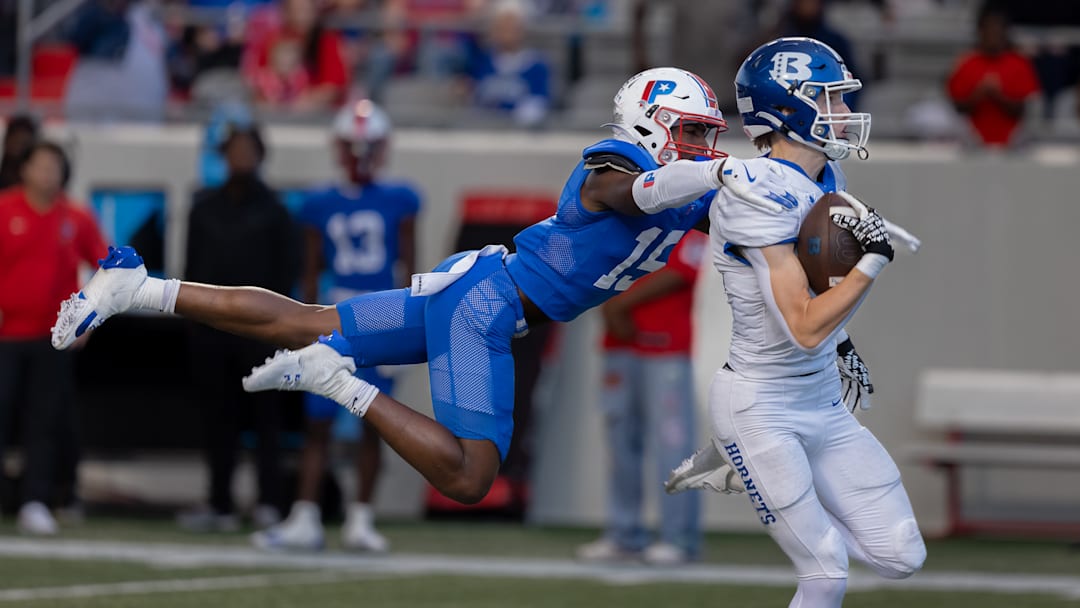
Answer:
[{"left": 243, "top": 330, "right": 356, "bottom": 396}]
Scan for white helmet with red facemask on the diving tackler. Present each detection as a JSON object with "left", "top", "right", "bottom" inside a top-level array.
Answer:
[{"left": 605, "top": 68, "right": 728, "bottom": 164}]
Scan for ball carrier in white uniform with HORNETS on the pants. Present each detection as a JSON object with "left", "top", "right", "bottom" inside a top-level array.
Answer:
[{"left": 710, "top": 38, "right": 926, "bottom": 608}]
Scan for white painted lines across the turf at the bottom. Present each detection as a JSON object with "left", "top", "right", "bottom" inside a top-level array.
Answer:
[{"left": 0, "top": 538, "right": 1080, "bottom": 599}]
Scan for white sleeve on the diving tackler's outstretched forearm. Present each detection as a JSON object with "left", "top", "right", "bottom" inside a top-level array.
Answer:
[{"left": 634, "top": 159, "right": 724, "bottom": 215}]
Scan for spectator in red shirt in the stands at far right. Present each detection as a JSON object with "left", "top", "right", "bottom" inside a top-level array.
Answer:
[{"left": 948, "top": 3, "right": 1039, "bottom": 148}]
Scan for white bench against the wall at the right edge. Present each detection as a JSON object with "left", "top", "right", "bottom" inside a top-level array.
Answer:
[{"left": 906, "top": 369, "right": 1080, "bottom": 533}]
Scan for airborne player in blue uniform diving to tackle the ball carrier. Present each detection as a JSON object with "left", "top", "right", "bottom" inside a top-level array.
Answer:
[{"left": 53, "top": 68, "right": 782, "bottom": 503}]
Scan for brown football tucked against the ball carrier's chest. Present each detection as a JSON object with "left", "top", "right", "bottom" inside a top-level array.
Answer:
[{"left": 796, "top": 192, "right": 863, "bottom": 294}]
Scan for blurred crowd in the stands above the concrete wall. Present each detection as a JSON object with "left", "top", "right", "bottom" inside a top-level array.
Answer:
[{"left": 0, "top": 0, "right": 1080, "bottom": 145}]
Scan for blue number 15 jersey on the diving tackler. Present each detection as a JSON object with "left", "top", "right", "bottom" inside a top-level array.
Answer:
[{"left": 507, "top": 139, "right": 715, "bottom": 321}]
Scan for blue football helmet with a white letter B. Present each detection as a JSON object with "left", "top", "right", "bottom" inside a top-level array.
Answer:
[{"left": 735, "top": 38, "right": 870, "bottom": 161}]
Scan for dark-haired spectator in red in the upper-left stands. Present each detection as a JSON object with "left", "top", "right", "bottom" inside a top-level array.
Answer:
[{"left": 243, "top": 0, "right": 349, "bottom": 111}]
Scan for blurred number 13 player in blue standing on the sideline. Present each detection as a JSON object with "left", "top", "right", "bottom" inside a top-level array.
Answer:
[{"left": 252, "top": 99, "right": 420, "bottom": 552}]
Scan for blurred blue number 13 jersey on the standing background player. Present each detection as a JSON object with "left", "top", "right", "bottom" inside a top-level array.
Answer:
[{"left": 299, "top": 183, "right": 420, "bottom": 292}]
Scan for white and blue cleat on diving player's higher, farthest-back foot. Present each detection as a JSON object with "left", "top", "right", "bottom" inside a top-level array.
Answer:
[{"left": 52, "top": 247, "right": 146, "bottom": 350}]
